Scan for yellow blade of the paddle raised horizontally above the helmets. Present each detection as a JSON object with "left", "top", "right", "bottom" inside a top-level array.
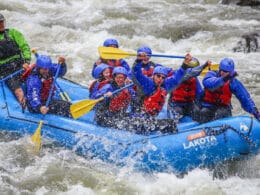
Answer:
[{"left": 98, "top": 47, "right": 137, "bottom": 60}]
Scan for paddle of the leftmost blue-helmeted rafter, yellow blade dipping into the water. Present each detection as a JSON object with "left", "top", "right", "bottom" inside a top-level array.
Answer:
[{"left": 31, "top": 64, "right": 61, "bottom": 150}]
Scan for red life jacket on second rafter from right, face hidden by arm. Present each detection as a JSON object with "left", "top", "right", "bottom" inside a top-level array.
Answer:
[{"left": 171, "top": 77, "right": 197, "bottom": 102}]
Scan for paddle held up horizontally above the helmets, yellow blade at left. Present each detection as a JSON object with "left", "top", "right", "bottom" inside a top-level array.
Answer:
[{"left": 98, "top": 47, "right": 185, "bottom": 60}]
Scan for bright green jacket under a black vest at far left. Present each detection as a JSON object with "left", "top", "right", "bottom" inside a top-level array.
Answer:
[{"left": 0, "top": 29, "right": 31, "bottom": 65}]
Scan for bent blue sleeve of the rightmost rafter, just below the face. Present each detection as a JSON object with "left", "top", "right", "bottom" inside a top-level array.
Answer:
[{"left": 202, "top": 71, "right": 225, "bottom": 91}]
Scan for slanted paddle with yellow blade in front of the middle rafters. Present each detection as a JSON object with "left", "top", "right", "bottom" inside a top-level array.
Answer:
[{"left": 70, "top": 83, "right": 133, "bottom": 119}]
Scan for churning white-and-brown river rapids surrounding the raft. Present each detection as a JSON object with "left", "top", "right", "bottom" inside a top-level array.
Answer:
[{"left": 0, "top": 0, "right": 260, "bottom": 195}]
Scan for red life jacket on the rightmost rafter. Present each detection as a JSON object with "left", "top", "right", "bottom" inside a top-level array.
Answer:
[{"left": 204, "top": 81, "right": 232, "bottom": 106}]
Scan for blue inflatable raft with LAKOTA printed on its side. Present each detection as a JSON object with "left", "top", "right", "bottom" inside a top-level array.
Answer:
[{"left": 0, "top": 79, "right": 260, "bottom": 174}]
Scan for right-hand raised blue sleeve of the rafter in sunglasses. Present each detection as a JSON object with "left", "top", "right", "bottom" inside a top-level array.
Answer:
[{"left": 163, "top": 68, "right": 185, "bottom": 92}]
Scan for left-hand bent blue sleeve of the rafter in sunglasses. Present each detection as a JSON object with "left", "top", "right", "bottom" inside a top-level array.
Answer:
[{"left": 132, "top": 61, "right": 156, "bottom": 96}]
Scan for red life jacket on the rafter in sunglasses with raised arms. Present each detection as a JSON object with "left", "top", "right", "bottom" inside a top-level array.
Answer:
[{"left": 143, "top": 87, "right": 167, "bottom": 116}]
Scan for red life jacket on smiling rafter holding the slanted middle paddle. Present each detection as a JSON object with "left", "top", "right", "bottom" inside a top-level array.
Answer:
[{"left": 109, "top": 89, "right": 131, "bottom": 112}]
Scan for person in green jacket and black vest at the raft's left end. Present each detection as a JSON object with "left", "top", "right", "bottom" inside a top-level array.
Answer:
[{"left": 0, "top": 13, "right": 31, "bottom": 108}]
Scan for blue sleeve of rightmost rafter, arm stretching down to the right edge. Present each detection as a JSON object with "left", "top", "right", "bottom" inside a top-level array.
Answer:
[{"left": 230, "top": 79, "right": 257, "bottom": 114}]
